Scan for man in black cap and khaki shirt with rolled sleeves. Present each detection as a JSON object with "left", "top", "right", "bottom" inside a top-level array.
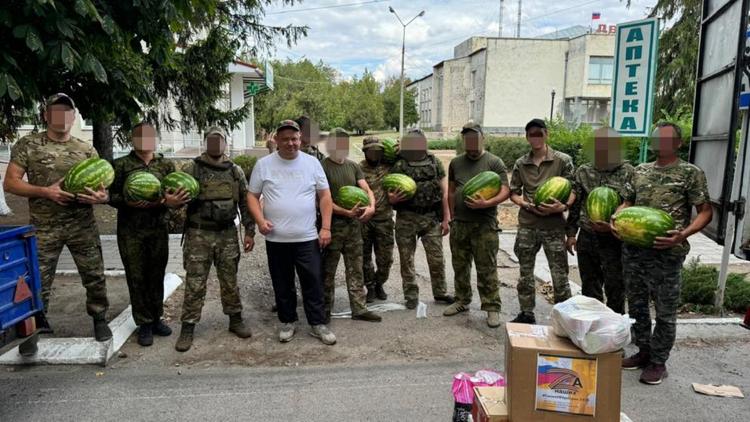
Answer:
[{"left": 510, "top": 119, "right": 575, "bottom": 324}]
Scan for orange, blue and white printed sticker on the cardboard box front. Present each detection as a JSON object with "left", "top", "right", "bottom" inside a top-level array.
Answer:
[{"left": 536, "top": 354, "right": 597, "bottom": 416}]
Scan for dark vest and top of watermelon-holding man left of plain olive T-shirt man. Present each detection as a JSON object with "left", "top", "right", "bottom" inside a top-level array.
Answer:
[{"left": 391, "top": 152, "right": 445, "bottom": 215}]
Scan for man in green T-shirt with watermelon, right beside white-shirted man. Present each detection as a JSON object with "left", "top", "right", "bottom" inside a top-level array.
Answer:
[{"left": 321, "top": 128, "right": 382, "bottom": 322}]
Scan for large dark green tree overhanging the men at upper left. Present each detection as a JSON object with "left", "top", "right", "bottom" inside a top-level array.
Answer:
[{"left": 0, "top": 0, "right": 307, "bottom": 158}]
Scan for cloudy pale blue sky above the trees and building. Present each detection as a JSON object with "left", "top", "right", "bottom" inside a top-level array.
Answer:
[{"left": 264, "top": 0, "right": 657, "bottom": 82}]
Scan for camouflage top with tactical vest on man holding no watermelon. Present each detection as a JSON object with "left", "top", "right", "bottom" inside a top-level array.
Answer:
[{"left": 182, "top": 153, "right": 255, "bottom": 233}]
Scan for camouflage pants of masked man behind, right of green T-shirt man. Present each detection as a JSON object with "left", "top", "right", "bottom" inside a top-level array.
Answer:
[{"left": 362, "top": 218, "right": 394, "bottom": 290}]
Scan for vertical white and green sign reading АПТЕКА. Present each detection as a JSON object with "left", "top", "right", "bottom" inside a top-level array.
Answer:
[{"left": 610, "top": 18, "right": 659, "bottom": 137}]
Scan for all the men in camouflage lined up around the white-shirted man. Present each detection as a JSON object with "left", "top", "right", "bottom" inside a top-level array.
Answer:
[{"left": 4, "top": 94, "right": 711, "bottom": 384}]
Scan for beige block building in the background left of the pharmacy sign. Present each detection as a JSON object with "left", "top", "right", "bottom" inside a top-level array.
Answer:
[{"left": 407, "top": 27, "right": 615, "bottom": 135}]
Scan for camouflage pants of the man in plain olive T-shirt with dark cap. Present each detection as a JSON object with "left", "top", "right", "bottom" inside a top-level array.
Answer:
[{"left": 450, "top": 220, "right": 500, "bottom": 312}]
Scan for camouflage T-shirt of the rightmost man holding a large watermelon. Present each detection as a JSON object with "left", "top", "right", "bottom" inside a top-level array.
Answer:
[{"left": 634, "top": 159, "right": 710, "bottom": 255}]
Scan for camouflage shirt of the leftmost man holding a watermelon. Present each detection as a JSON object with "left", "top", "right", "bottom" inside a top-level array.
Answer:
[{"left": 10, "top": 132, "right": 99, "bottom": 225}]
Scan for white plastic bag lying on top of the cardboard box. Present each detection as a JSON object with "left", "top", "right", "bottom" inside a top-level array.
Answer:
[{"left": 552, "top": 295, "right": 630, "bottom": 355}]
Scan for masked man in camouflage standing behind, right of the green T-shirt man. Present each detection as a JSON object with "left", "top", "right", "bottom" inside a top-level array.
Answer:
[{"left": 359, "top": 136, "right": 394, "bottom": 303}]
